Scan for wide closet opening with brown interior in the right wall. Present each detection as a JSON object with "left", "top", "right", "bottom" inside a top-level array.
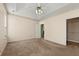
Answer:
[{"left": 67, "top": 17, "right": 79, "bottom": 47}]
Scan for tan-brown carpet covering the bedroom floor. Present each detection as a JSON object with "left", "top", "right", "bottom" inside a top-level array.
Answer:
[{"left": 2, "top": 39, "right": 79, "bottom": 56}]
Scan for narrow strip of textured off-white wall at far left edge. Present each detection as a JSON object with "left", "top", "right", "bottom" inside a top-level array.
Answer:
[{"left": 0, "top": 3, "right": 7, "bottom": 55}]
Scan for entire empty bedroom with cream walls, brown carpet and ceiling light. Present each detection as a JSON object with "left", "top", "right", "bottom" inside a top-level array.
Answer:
[{"left": 0, "top": 3, "right": 79, "bottom": 56}]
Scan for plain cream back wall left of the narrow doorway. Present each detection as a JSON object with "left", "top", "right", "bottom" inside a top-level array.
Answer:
[{"left": 8, "top": 14, "right": 38, "bottom": 42}]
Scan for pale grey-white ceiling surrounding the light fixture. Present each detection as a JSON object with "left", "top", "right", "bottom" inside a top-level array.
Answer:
[{"left": 5, "top": 3, "right": 79, "bottom": 20}]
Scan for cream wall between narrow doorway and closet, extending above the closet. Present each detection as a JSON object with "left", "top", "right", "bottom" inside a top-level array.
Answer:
[{"left": 39, "top": 9, "right": 79, "bottom": 45}]
